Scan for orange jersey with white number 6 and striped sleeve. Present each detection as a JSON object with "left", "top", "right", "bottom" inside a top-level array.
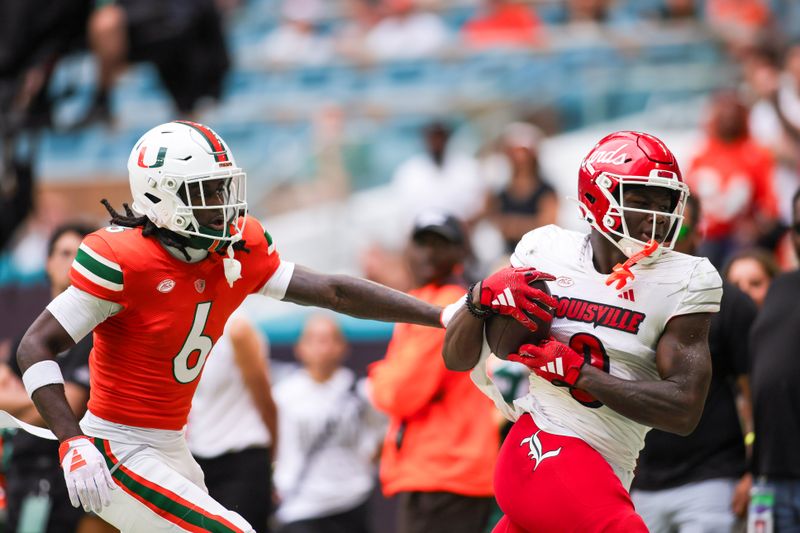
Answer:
[{"left": 70, "top": 217, "right": 280, "bottom": 430}]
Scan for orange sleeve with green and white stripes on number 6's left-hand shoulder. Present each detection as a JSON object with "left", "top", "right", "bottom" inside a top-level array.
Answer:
[{"left": 69, "top": 232, "right": 125, "bottom": 303}]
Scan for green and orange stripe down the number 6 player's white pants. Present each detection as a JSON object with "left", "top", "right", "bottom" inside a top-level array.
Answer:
[{"left": 92, "top": 438, "right": 246, "bottom": 533}]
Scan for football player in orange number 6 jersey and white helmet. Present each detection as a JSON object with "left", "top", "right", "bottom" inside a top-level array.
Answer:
[{"left": 17, "top": 121, "right": 544, "bottom": 532}]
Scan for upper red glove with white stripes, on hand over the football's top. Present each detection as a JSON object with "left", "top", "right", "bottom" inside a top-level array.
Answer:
[{"left": 480, "top": 267, "right": 558, "bottom": 331}]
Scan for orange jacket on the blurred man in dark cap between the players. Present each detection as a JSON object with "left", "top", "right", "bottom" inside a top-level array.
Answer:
[{"left": 369, "top": 284, "right": 500, "bottom": 496}]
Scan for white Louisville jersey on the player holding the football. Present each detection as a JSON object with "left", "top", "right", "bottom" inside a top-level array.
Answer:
[{"left": 474, "top": 225, "right": 722, "bottom": 487}]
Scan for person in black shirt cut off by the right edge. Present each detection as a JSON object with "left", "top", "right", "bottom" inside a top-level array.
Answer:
[{"left": 750, "top": 190, "right": 800, "bottom": 531}]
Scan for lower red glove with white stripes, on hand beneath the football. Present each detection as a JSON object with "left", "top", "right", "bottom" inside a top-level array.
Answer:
[{"left": 508, "top": 337, "right": 589, "bottom": 387}]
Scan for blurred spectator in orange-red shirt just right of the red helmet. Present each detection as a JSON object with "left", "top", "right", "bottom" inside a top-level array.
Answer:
[{"left": 686, "top": 92, "right": 778, "bottom": 268}]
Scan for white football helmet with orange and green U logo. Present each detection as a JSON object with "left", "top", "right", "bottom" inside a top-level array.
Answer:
[{"left": 128, "top": 121, "right": 247, "bottom": 248}]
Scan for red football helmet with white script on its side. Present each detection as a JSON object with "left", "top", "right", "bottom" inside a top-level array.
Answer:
[{"left": 578, "top": 131, "right": 689, "bottom": 261}]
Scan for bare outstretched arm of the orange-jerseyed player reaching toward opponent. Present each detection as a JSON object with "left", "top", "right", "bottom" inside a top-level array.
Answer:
[{"left": 283, "top": 265, "right": 442, "bottom": 328}]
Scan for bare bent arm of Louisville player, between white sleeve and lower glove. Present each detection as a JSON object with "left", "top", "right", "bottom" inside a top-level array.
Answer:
[{"left": 575, "top": 313, "right": 711, "bottom": 435}]
